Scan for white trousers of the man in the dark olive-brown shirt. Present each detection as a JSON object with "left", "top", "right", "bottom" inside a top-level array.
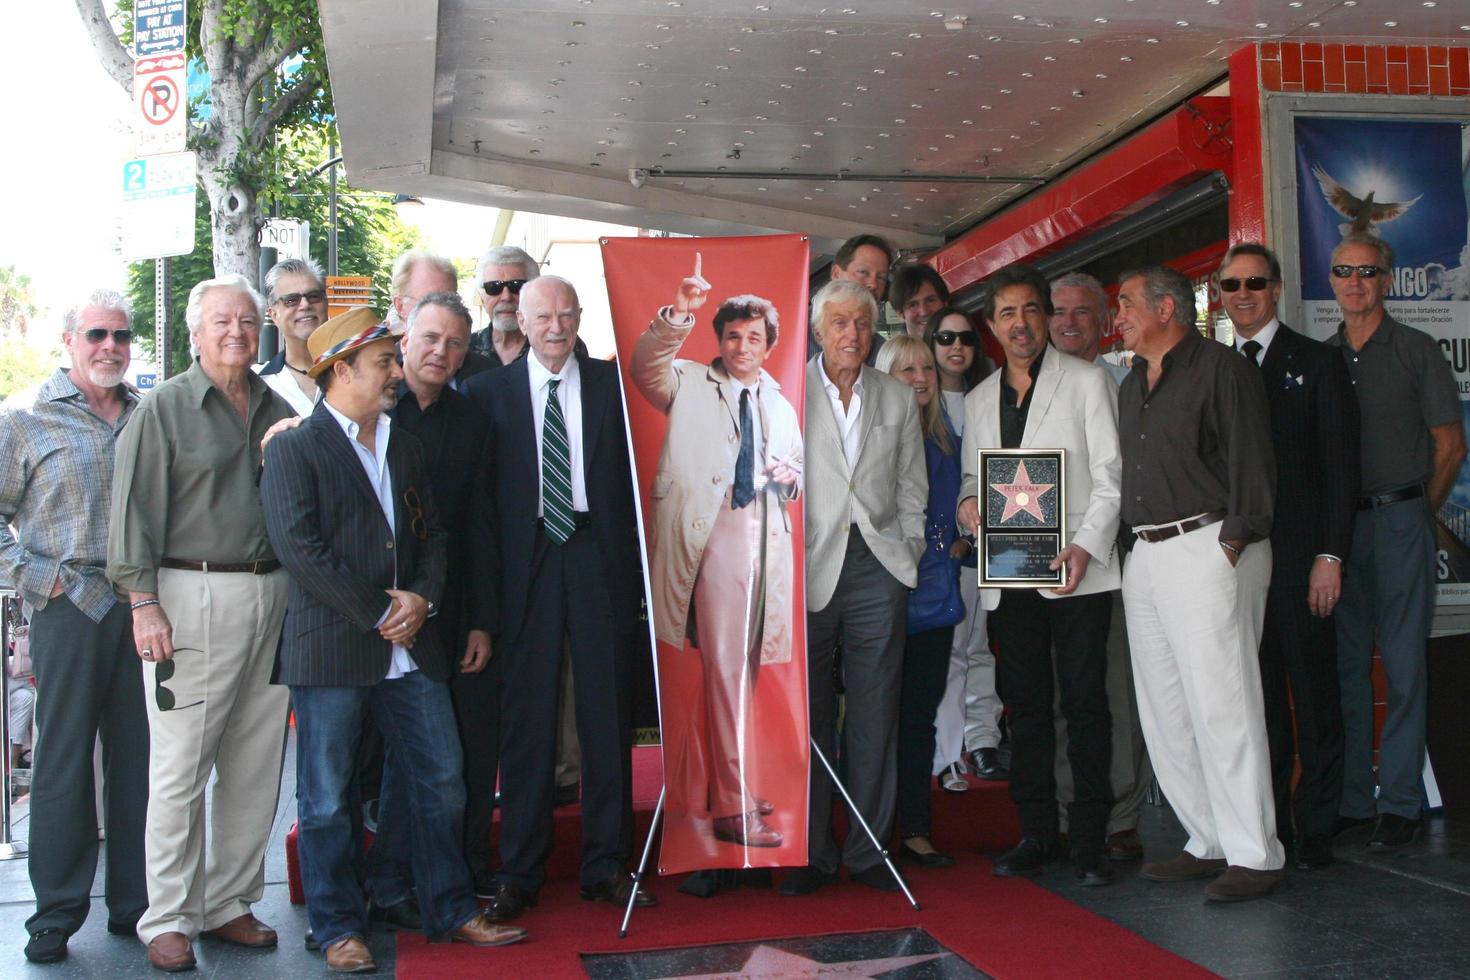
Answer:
[{"left": 1123, "top": 525, "right": 1285, "bottom": 871}]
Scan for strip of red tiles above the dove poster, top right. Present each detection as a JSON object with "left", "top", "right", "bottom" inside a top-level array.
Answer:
[{"left": 1260, "top": 41, "right": 1470, "bottom": 96}]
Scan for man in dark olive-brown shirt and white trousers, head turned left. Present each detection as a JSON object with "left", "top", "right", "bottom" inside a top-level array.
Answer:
[{"left": 1117, "top": 266, "right": 1285, "bottom": 902}]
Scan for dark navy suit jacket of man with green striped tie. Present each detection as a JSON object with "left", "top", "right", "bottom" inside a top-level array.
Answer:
[{"left": 465, "top": 356, "right": 642, "bottom": 642}]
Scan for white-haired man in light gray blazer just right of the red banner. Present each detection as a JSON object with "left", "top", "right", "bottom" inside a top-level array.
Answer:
[{"left": 781, "top": 281, "right": 929, "bottom": 895}]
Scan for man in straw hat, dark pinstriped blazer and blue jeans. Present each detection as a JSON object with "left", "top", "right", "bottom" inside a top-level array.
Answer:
[{"left": 260, "top": 309, "right": 525, "bottom": 973}]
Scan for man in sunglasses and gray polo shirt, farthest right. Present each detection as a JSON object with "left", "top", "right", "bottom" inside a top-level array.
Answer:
[{"left": 1327, "top": 232, "right": 1466, "bottom": 851}]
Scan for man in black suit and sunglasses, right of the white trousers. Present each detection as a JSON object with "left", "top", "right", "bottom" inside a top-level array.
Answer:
[{"left": 1217, "top": 242, "right": 1358, "bottom": 871}]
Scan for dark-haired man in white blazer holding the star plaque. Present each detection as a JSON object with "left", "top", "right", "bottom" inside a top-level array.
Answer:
[{"left": 957, "top": 264, "right": 1122, "bottom": 884}]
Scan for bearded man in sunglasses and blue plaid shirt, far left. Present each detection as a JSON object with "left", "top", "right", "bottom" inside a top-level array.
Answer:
[{"left": 0, "top": 289, "right": 148, "bottom": 962}]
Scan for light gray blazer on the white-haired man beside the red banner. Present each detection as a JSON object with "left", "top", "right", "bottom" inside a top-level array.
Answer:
[{"left": 806, "top": 354, "right": 929, "bottom": 613}]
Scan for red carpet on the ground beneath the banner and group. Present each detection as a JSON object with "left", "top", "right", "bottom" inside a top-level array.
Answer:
[{"left": 397, "top": 749, "right": 1213, "bottom": 980}]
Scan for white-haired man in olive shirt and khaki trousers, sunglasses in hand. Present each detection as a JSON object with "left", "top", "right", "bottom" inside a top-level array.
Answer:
[{"left": 107, "top": 276, "right": 293, "bottom": 971}]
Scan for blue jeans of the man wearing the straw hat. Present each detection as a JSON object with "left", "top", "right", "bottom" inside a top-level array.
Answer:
[{"left": 291, "top": 670, "right": 479, "bottom": 949}]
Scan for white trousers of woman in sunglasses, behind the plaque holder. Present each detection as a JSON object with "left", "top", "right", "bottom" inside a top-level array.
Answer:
[{"left": 933, "top": 566, "right": 1003, "bottom": 774}]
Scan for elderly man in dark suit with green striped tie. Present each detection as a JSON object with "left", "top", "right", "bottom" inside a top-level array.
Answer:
[{"left": 466, "top": 276, "right": 654, "bottom": 921}]
